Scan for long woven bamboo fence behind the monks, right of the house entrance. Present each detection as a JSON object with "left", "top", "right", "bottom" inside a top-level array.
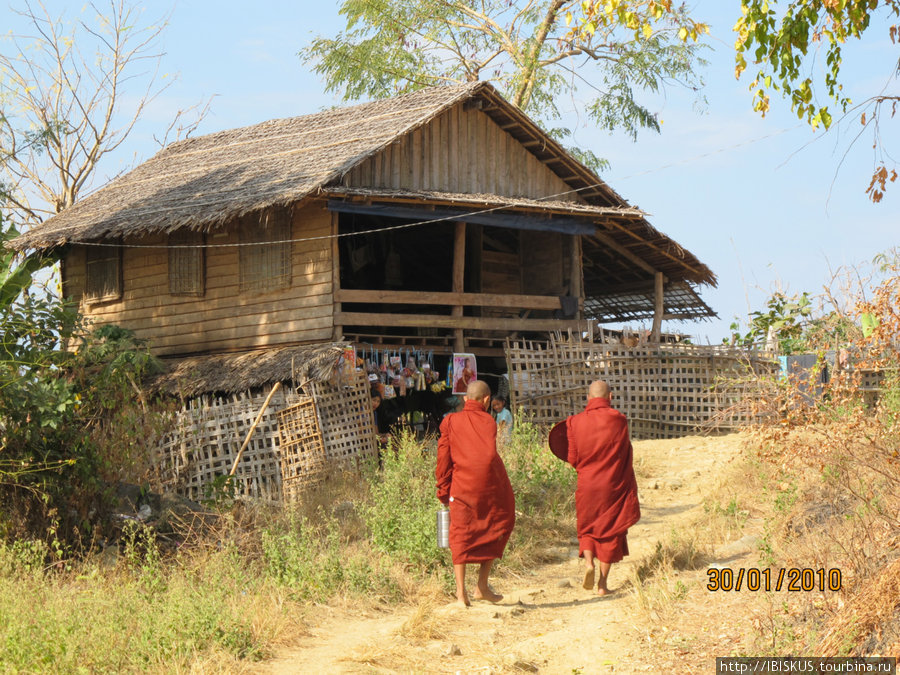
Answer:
[{"left": 506, "top": 336, "right": 779, "bottom": 439}]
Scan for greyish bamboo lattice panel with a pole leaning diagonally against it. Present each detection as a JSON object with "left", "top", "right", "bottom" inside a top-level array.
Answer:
[{"left": 160, "top": 390, "right": 293, "bottom": 501}]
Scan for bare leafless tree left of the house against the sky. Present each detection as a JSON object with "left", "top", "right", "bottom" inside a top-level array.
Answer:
[{"left": 0, "top": 0, "right": 206, "bottom": 225}]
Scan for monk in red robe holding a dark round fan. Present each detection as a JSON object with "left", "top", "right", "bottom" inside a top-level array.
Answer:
[{"left": 566, "top": 380, "right": 641, "bottom": 595}]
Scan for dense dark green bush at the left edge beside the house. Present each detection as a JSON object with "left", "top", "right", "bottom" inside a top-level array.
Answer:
[{"left": 0, "top": 231, "right": 163, "bottom": 538}]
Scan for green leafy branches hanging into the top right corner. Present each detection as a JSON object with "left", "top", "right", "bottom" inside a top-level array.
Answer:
[{"left": 734, "top": 0, "right": 900, "bottom": 202}]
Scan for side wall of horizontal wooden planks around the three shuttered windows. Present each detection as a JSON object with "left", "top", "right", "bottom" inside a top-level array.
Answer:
[{"left": 65, "top": 202, "right": 334, "bottom": 356}]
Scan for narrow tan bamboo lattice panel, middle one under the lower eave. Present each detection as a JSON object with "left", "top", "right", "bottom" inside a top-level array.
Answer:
[{"left": 278, "top": 396, "right": 327, "bottom": 501}]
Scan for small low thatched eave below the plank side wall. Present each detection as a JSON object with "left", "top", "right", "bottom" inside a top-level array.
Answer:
[{"left": 149, "top": 342, "right": 349, "bottom": 398}]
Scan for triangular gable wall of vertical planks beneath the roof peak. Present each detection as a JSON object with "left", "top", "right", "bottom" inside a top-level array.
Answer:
[{"left": 344, "top": 104, "right": 583, "bottom": 202}]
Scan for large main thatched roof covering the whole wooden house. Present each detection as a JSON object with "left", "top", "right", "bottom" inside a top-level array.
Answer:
[{"left": 8, "top": 82, "right": 716, "bottom": 298}]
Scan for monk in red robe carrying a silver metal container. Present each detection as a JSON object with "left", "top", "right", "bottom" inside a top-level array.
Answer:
[{"left": 435, "top": 380, "right": 516, "bottom": 606}]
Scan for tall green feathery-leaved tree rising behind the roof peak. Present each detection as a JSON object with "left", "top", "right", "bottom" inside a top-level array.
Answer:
[{"left": 300, "top": 0, "right": 705, "bottom": 168}]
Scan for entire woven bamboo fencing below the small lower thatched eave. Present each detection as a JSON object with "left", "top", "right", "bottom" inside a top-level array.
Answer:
[{"left": 158, "top": 372, "right": 378, "bottom": 502}]
